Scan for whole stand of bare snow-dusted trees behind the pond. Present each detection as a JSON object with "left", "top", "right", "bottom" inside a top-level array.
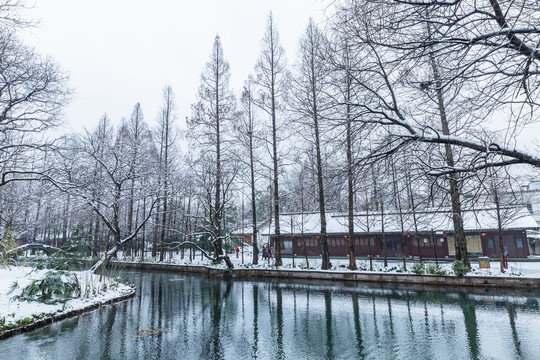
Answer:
[{"left": 0, "top": 0, "right": 540, "bottom": 269}]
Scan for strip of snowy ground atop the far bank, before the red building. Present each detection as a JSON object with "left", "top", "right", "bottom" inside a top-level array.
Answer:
[{"left": 114, "top": 249, "right": 540, "bottom": 278}]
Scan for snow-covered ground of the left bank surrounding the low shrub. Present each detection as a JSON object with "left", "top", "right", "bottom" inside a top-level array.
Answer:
[{"left": 0, "top": 266, "right": 133, "bottom": 332}]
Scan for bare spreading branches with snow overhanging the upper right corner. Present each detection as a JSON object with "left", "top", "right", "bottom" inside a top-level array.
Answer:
[{"left": 333, "top": 0, "right": 540, "bottom": 173}]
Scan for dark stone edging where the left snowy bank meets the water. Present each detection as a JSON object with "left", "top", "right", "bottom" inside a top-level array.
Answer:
[{"left": 0, "top": 286, "right": 137, "bottom": 340}]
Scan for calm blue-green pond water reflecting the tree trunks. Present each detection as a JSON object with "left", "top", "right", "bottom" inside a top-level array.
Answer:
[{"left": 0, "top": 271, "right": 540, "bottom": 360}]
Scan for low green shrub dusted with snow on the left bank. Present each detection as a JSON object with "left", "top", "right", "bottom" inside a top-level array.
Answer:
[{"left": 16, "top": 271, "right": 81, "bottom": 304}]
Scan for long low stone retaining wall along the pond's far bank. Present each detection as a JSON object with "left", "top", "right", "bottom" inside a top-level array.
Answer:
[{"left": 109, "top": 262, "right": 540, "bottom": 289}]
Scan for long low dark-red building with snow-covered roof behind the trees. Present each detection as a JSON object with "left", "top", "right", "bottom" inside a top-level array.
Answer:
[{"left": 259, "top": 208, "right": 538, "bottom": 258}]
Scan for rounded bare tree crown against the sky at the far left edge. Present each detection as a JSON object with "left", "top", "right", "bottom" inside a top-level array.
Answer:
[{"left": 0, "top": 27, "right": 69, "bottom": 186}]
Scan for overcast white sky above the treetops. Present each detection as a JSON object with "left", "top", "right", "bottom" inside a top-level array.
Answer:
[{"left": 23, "top": 0, "right": 329, "bottom": 130}]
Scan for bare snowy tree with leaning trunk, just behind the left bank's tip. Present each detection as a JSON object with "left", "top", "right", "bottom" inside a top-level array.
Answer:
[{"left": 48, "top": 117, "right": 158, "bottom": 272}]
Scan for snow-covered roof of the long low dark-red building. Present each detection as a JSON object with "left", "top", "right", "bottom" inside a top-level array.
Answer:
[{"left": 259, "top": 207, "right": 539, "bottom": 236}]
